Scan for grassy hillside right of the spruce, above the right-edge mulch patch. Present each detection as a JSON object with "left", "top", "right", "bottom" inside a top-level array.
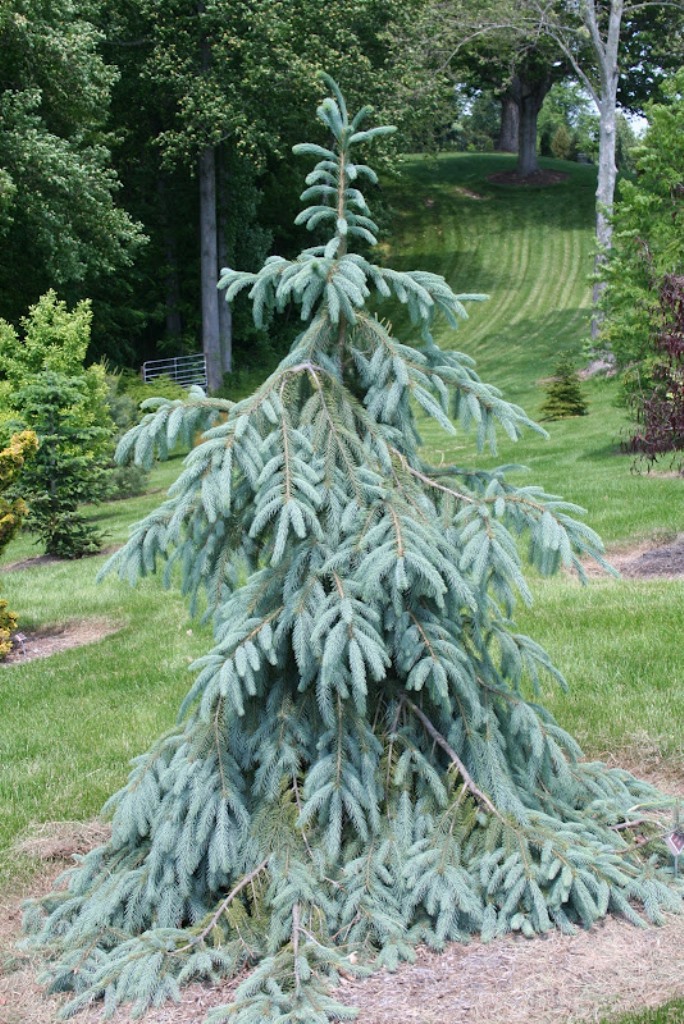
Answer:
[{"left": 386, "top": 154, "right": 684, "bottom": 544}]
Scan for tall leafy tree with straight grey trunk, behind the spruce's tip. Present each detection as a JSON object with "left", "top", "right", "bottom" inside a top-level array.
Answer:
[{"left": 129, "top": 0, "right": 420, "bottom": 391}]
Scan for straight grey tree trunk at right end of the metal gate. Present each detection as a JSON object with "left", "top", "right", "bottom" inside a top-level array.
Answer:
[{"left": 200, "top": 145, "right": 223, "bottom": 392}]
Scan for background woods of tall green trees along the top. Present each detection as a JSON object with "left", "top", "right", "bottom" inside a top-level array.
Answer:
[{"left": 0, "top": 0, "right": 682, "bottom": 390}]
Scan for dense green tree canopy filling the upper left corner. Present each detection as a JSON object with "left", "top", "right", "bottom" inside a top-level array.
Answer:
[{"left": 0, "top": 0, "right": 143, "bottom": 331}]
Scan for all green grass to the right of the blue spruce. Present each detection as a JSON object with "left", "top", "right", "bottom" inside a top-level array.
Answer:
[{"left": 389, "top": 154, "right": 684, "bottom": 763}]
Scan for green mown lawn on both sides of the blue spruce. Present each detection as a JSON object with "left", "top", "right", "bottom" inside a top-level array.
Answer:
[{"left": 0, "top": 155, "right": 684, "bottom": 1024}]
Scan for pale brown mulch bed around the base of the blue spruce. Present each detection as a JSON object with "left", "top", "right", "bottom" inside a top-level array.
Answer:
[{"left": 0, "top": 806, "right": 684, "bottom": 1024}]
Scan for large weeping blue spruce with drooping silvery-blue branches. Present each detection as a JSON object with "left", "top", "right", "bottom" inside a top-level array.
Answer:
[{"left": 24, "top": 80, "right": 681, "bottom": 1024}]
